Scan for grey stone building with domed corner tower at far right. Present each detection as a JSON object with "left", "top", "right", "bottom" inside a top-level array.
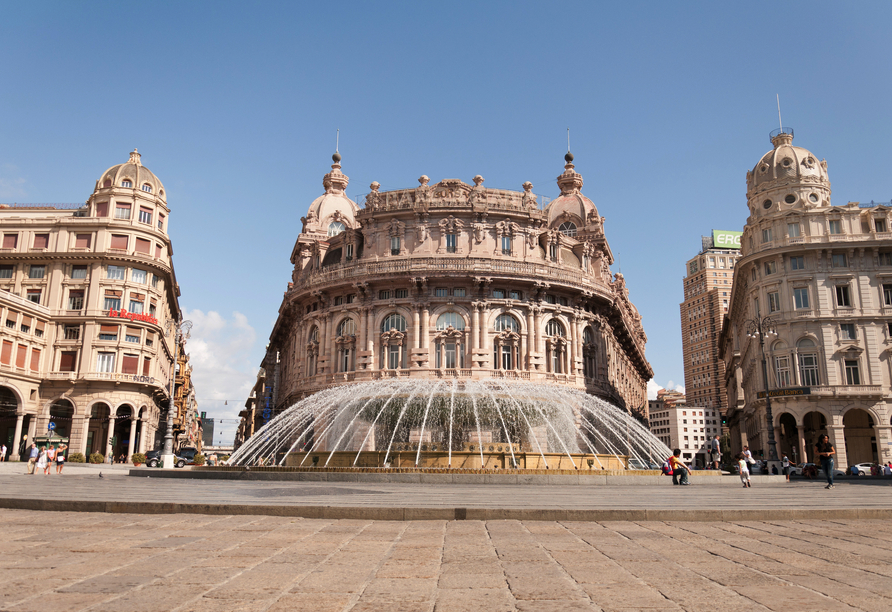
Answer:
[{"left": 720, "top": 128, "right": 892, "bottom": 469}]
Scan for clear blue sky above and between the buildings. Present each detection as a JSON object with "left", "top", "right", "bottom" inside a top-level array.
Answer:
[{"left": 0, "top": 1, "right": 892, "bottom": 440}]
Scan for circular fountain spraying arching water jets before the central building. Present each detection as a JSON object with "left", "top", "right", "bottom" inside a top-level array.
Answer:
[{"left": 228, "top": 380, "right": 671, "bottom": 470}]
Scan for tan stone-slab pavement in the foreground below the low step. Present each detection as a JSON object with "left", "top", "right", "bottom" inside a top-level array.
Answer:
[{"left": 0, "top": 510, "right": 892, "bottom": 612}]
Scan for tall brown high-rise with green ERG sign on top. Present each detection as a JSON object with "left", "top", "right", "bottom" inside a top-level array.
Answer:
[{"left": 680, "top": 232, "right": 740, "bottom": 414}]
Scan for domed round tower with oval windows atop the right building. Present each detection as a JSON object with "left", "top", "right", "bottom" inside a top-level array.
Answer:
[{"left": 746, "top": 128, "right": 830, "bottom": 221}]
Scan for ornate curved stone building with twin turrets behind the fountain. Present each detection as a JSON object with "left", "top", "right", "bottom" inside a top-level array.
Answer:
[{"left": 254, "top": 153, "right": 652, "bottom": 430}]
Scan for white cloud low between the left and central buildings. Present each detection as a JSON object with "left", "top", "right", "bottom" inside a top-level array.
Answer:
[{"left": 183, "top": 309, "right": 260, "bottom": 444}]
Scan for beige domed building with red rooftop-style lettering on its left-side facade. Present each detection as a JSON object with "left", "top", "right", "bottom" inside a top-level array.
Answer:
[{"left": 0, "top": 150, "right": 180, "bottom": 459}]
